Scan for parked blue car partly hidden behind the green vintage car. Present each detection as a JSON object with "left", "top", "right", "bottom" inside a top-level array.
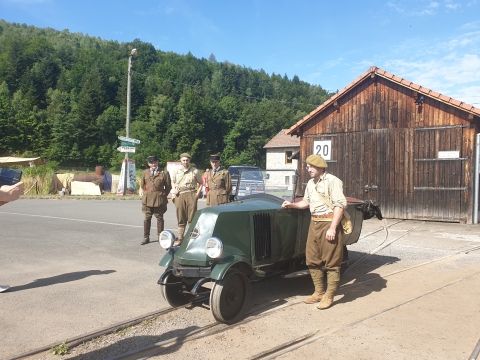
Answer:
[{"left": 228, "top": 165, "right": 265, "bottom": 200}]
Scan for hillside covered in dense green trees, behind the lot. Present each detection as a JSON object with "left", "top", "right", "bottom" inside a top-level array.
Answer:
[{"left": 0, "top": 20, "right": 329, "bottom": 167}]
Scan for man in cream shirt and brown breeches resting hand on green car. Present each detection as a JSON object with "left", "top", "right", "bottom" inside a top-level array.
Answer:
[{"left": 282, "top": 155, "right": 347, "bottom": 309}]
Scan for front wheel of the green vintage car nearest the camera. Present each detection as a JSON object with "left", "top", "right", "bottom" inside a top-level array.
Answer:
[{"left": 210, "top": 270, "right": 250, "bottom": 324}]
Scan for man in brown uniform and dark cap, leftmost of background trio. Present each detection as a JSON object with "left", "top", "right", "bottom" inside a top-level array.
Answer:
[{"left": 140, "top": 156, "right": 172, "bottom": 245}]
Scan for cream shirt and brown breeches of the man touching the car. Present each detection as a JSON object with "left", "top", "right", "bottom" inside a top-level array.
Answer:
[{"left": 303, "top": 173, "right": 347, "bottom": 269}]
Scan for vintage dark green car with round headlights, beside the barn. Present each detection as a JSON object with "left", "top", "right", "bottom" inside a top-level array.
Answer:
[{"left": 158, "top": 169, "right": 375, "bottom": 323}]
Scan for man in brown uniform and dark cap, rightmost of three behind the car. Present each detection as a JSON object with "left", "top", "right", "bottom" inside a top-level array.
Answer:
[{"left": 207, "top": 154, "right": 232, "bottom": 206}]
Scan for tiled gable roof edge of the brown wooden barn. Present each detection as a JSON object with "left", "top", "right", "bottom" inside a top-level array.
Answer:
[{"left": 286, "top": 66, "right": 480, "bottom": 135}]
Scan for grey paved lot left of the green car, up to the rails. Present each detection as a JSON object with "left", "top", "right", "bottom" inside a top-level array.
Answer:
[{"left": 0, "top": 199, "right": 203, "bottom": 358}]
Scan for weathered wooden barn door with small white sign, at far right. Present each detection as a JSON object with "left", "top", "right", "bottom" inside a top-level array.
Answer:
[{"left": 413, "top": 126, "right": 467, "bottom": 221}]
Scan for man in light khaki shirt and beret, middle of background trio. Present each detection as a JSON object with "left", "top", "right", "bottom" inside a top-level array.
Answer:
[{"left": 172, "top": 153, "right": 202, "bottom": 245}]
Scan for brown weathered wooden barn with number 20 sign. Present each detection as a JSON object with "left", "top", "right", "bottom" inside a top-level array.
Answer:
[{"left": 287, "top": 67, "right": 480, "bottom": 224}]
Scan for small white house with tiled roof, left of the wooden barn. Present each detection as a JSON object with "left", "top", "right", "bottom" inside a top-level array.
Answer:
[{"left": 264, "top": 129, "right": 300, "bottom": 190}]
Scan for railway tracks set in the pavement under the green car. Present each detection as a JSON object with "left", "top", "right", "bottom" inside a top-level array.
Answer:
[{"left": 9, "top": 221, "right": 480, "bottom": 360}]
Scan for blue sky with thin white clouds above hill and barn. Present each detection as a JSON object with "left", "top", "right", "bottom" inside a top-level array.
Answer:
[{"left": 0, "top": 0, "right": 480, "bottom": 107}]
